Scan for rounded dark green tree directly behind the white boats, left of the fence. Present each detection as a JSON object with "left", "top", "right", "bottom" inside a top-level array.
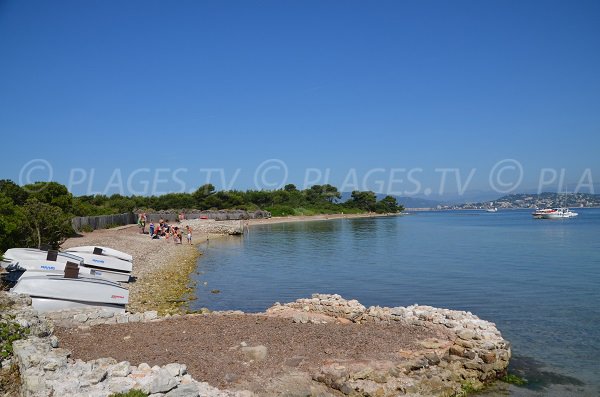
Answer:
[{"left": 23, "top": 197, "right": 73, "bottom": 249}]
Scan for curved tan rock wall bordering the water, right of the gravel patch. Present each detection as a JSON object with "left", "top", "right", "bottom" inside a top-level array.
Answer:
[{"left": 267, "top": 294, "right": 511, "bottom": 396}]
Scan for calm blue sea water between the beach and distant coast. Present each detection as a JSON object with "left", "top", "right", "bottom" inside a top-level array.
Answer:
[{"left": 193, "top": 209, "right": 600, "bottom": 396}]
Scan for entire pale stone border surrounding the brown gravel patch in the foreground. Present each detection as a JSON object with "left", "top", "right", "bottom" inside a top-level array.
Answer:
[{"left": 0, "top": 294, "right": 511, "bottom": 397}]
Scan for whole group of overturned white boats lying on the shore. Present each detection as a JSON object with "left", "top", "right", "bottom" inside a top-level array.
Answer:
[{"left": 0, "top": 246, "right": 133, "bottom": 312}]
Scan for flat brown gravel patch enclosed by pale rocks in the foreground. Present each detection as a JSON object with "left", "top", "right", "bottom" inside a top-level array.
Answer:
[{"left": 57, "top": 314, "right": 448, "bottom": 396}]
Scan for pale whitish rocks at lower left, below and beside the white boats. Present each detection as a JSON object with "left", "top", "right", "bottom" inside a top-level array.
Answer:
[{"left": 0, "top": 293, "right": 252, "bottom": 397}]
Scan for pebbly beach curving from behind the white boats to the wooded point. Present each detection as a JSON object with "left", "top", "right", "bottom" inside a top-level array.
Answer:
[{"left": 62, "top": 213, "right": 401, "bottom": 315}]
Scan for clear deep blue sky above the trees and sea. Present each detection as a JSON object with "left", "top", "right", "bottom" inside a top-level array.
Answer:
[{"left": 0, "top": 0, "right": 600, "bottom": 195}]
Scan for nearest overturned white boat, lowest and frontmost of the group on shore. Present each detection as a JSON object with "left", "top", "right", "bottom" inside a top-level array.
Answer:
[{"left": 10, "top": 272, "right": 129, "bottom": 312}]
